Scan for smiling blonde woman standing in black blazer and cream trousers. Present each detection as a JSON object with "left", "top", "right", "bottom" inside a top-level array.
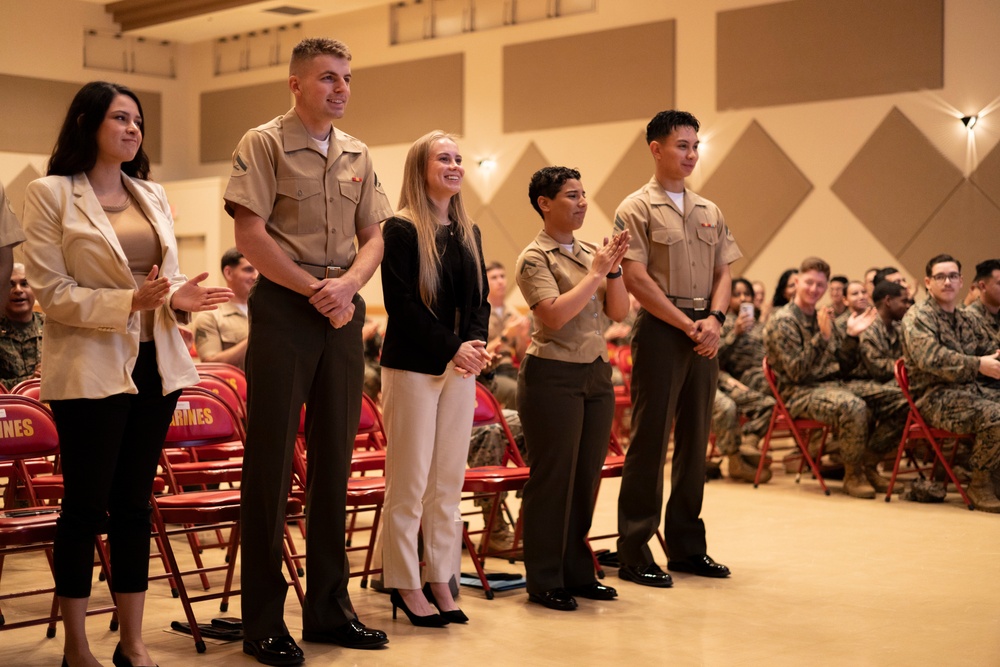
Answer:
[{"left": 381, "top": 131, "right": 490, "bottom": 627}]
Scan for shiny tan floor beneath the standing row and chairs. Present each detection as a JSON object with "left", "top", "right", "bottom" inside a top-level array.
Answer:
[{"left": 0, "top": 448, "right": 1000, "bottom": 667}]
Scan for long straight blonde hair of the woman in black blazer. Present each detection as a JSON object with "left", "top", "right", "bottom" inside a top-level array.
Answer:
[{"left": 398, "top": 130, "right": 483, "bottom": 310}]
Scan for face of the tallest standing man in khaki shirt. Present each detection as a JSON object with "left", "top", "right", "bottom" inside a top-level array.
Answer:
[{"left": 288, "top": 55, "right": 351, "bottom": 123}]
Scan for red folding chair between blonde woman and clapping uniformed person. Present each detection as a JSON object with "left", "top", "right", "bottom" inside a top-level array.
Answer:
[{"left": 462, "top": 382, "right": 528, "bottom": 600}]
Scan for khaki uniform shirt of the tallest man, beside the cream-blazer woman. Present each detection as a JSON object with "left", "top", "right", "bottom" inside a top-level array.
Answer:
[{"left": 224, "top": 109, "right": 392, "bottom": 267}]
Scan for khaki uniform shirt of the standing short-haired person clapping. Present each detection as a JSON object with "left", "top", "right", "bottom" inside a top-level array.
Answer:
[{"left": 516, "top": 230, "right": 610, "bottom": 364}]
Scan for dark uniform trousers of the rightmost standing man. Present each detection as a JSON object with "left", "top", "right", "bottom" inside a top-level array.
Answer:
[{"left": 618, "top": 310, "right": 719, "bottom": 565}]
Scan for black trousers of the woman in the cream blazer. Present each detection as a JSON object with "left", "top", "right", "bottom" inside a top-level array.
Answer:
[{"left": 51, "top": 342, "right": 180, "bottom": 598}]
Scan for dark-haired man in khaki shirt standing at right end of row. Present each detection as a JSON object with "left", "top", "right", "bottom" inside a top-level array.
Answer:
[{"left": 615, "top": 110, "right": 742, "bottom": 588}]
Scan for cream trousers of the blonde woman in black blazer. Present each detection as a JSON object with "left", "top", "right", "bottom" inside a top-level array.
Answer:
[{"left": 380, "top": 363, "right": 476, "bottom": 589}]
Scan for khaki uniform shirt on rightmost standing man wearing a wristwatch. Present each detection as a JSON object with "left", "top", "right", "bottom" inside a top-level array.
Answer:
[{"left": 615, "top": 177, "right": 743, "bottom": 299}]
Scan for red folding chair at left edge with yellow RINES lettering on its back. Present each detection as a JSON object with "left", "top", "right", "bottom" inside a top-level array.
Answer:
[{"left": 0, "top": 394, "right": 118, "bottom": 638}]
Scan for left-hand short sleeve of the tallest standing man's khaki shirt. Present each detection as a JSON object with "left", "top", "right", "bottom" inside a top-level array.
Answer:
[{"left": 223, "top": 130, "right": 281, "bottom": 220}]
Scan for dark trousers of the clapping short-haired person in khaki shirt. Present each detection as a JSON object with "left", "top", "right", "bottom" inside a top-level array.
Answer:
[{"left": 517, "top": 355, "right": 615, "bottom": 593}]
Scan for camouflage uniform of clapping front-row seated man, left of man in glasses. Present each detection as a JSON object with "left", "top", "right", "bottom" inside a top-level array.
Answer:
[{"left": 764, "top": 302, "right": 906, "bottom": 464}]
